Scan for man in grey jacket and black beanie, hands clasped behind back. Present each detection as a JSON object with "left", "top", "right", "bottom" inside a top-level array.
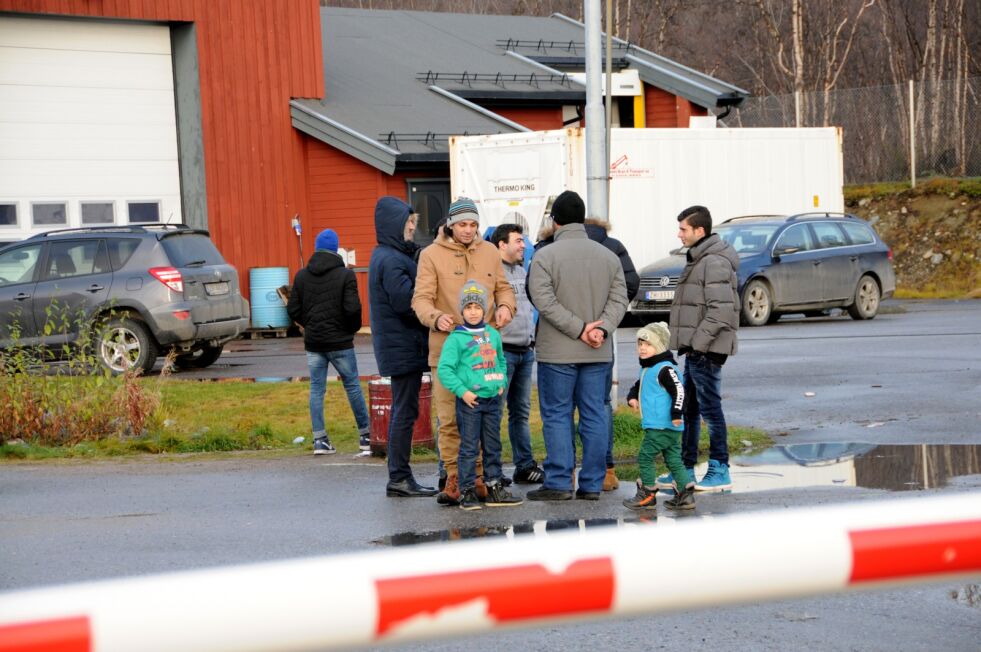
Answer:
[{"left": 528, "top": 191, "right": 627, "bottom": 500}]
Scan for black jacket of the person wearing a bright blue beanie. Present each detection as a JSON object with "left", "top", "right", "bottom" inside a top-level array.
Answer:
[{"left": 286, "top": 251, "right": 361, "bottom": 353}]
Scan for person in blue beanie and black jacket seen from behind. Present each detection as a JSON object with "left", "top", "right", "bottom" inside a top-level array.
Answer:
[{"left": 286, "top": 229, "right": 369, "bottom": 455}]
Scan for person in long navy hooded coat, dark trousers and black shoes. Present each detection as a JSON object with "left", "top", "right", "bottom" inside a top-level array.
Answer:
[{"left": 368, "top": 197, "right": 436, "bottom": 498}]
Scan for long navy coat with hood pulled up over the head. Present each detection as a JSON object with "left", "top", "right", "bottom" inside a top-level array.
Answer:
[{"left": 368, "top": 197, "right": 429, "bottom": 376}]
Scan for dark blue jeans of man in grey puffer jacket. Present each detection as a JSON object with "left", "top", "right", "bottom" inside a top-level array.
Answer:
[{"left": 681, "top": 353, "right": 729, "bottom": 469}]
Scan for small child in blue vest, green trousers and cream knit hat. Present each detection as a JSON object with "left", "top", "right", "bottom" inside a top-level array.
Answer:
[{"left": 623, "top": 322, "right": 695, "bottom": 511}]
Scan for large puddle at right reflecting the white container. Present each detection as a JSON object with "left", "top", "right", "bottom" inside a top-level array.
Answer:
[{"left": 728, "top": 443, "right": 981, "bottom": 492}]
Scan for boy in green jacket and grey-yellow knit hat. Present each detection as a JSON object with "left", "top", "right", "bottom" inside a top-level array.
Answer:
[{"left": 436, "top": 280, "right": 524, "bottom": 510}]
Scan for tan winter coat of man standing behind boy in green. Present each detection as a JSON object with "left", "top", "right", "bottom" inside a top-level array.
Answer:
[{"left": 412, "top": 231, "right": 517, "bottom": 367}]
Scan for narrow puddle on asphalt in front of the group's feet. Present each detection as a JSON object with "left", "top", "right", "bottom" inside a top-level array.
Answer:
[{"left": 371, "top": 514, "right": 657, "bottom": 546}]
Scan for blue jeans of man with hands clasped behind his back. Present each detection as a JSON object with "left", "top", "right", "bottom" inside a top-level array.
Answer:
[{"left": 538, "top": 362, "right": 609, "bottom": 493}]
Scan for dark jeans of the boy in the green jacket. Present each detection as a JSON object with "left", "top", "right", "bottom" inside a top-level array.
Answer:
[{"left": 456, "top": 396, "right": 501, "bottom": 491}]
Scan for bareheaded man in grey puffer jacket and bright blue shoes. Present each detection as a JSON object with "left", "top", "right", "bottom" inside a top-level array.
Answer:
[{"left": 658, "top": 206, "right": 739, "bottom": 491}]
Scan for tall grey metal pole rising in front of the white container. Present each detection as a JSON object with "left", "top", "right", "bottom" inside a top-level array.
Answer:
[{"left": 584, "top": 0, "right": 610, "bottom": 220}]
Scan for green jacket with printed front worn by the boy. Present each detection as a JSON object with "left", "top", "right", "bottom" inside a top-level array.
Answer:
[{"left": 436, "top": 325, "right": 508, "bottom": 398}]
